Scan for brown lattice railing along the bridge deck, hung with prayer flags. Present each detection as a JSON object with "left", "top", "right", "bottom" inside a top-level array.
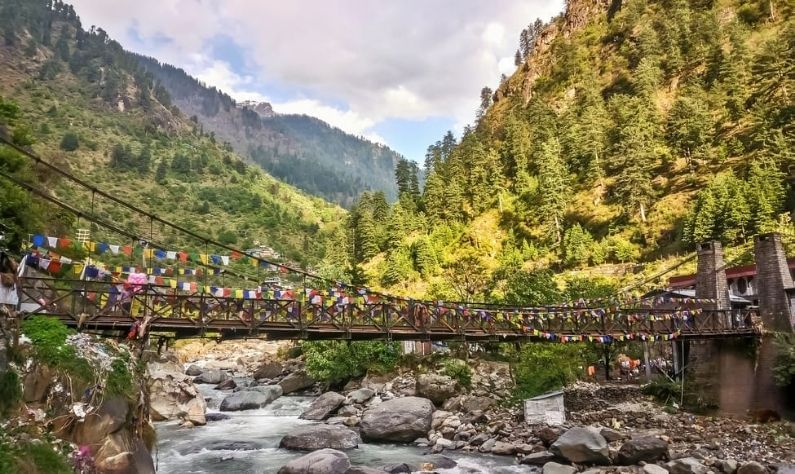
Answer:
[{"left": 14, "top": 277, "right": 753, "bottom": 339}]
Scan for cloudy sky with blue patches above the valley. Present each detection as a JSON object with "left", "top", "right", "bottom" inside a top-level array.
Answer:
[{"left": 72, "top": 0, "right": 563, "bottom": 161}]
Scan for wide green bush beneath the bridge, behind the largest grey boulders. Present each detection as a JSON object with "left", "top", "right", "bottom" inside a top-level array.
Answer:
[{"left": 302, "top": 341, "right": 400, "bottom": 383}]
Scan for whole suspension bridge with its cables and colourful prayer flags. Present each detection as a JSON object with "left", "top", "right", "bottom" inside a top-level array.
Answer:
[{"left": 0, "top": 137, "right": 776, "bottom": 343}]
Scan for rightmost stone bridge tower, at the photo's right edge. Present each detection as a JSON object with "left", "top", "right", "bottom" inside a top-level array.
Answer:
[{"left": 754, "top": 233, "right": 795, "bottom": 332}]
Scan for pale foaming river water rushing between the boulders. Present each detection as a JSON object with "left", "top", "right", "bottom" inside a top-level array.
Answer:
[{"left": 155, "top": 379, "right": 534, "bottom": 474}]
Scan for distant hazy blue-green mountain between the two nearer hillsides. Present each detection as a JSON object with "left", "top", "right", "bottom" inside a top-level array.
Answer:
[{"left": 136, "top": 56, "right": 401, "bottom": 207}]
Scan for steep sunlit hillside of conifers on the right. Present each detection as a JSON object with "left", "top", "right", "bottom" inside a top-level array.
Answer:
[{"left": 351, "top": 0, "right": 795, "bottom": 303}]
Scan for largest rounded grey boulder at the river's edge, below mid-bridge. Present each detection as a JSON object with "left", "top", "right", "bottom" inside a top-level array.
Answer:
[{"left": 360, "top": 397, "right": 433, "bottom": 443}]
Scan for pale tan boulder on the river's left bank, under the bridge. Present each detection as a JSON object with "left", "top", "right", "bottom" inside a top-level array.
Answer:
[{"left": 147, "top": 362, "right": 207, "bottom": 425}]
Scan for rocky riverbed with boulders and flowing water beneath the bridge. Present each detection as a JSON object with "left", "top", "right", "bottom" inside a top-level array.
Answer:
[{"left": 150, "top": 342, "right": 795, "bottom": 474}]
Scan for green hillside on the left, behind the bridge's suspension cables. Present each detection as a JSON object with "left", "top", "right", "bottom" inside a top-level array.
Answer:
[{"left": 0, "top": 0, "right": 344, "bottom": 265}]
